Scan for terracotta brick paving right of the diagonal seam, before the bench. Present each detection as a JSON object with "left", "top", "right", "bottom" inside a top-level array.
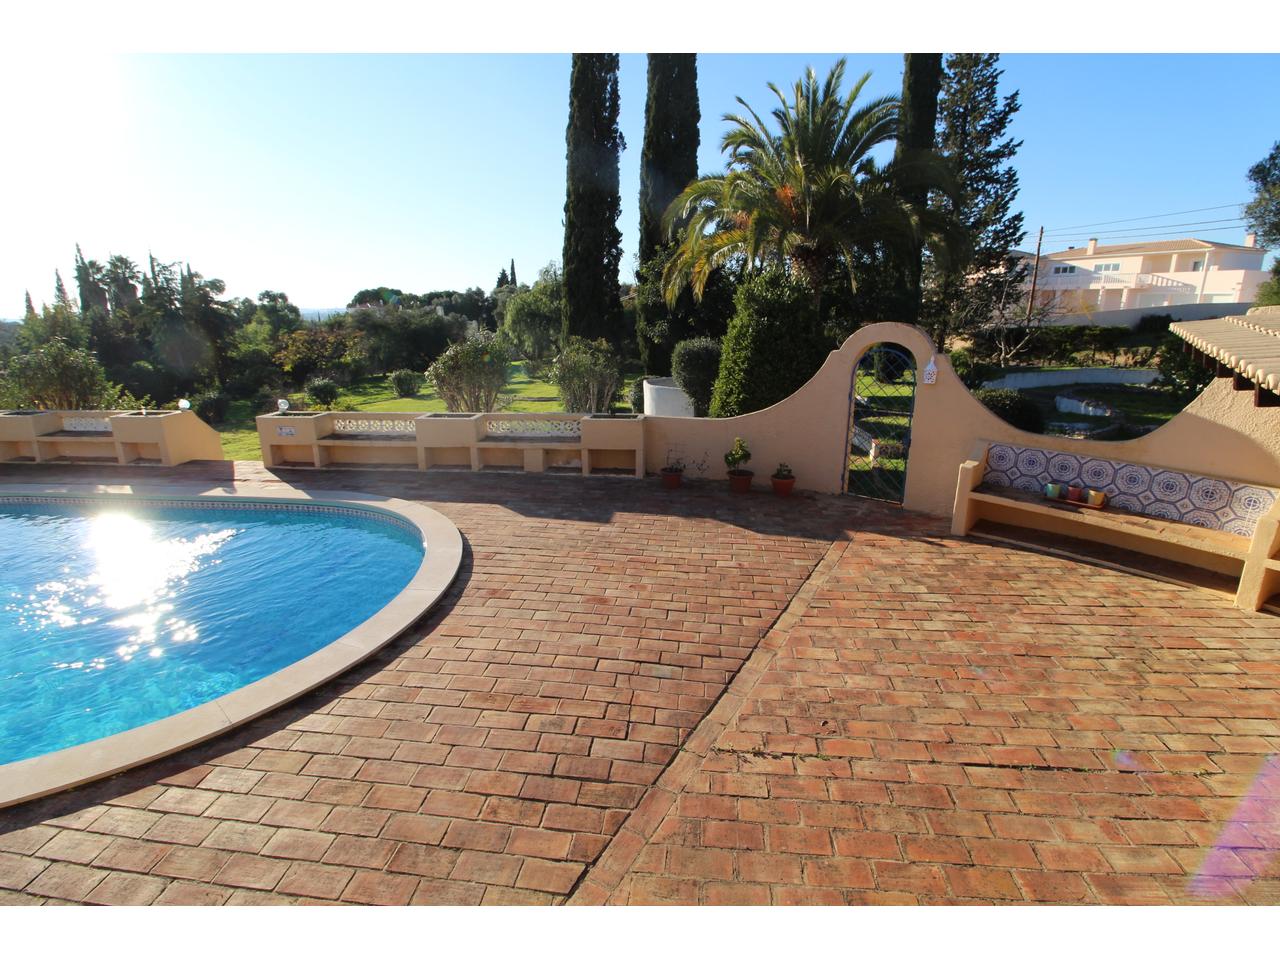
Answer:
[{"left": 588, "top": 518, "right": 1280, "bottom": 904}]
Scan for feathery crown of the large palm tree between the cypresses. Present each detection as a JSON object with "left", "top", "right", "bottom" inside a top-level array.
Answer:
[{"left": 663, "top": 59, "right": 950, "bottom": 303}]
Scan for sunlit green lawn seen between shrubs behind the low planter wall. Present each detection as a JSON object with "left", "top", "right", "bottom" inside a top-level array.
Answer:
[{"left": 216, "top": 361, "right": 636, "bottom": 460}]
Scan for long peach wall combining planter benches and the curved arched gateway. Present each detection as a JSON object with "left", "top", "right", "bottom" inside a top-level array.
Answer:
[{"left": 257, "top": 324, "right": 1280, "bottom": 516}]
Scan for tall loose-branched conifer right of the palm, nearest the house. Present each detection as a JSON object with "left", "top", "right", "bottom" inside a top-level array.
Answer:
[{"left": 924, "top": 54, "right": 1027, "bottom": 346}]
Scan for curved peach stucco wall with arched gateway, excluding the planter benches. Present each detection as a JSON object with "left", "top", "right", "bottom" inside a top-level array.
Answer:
[{"left": 645, "top": 324, "right": 1280, "bottom": 516}]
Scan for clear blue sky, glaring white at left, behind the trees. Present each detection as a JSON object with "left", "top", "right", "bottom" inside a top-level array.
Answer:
[{"left": 0, "top": 54, "right": 1280, "bottom": 317}]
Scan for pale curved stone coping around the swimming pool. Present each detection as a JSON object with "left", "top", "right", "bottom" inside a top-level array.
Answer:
[{"left": 0, "top": 483, "right": 462, "bottom": 809}]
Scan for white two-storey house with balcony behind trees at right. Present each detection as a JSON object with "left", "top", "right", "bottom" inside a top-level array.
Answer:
[{"left": 1036, "top": 233, "right": 1271, "bottom": 314}]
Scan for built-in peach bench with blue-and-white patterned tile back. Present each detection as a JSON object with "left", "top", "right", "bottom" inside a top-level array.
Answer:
[{"left": 951, "top": 443, "right": 1280, "bottom": 611}]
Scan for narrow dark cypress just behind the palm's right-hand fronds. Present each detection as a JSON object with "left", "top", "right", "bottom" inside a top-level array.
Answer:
[{"left": 893, "top": 54, "right": 942, "bottom": 324}]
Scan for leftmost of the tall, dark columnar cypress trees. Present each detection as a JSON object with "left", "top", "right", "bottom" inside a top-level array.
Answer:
[{"left": 562, "top": 54, "right": 626, "bottom": 343}]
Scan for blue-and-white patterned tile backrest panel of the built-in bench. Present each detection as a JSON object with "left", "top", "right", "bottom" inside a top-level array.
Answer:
[{"left": 983, "top": 443, "right": 1276, "bottom": 536}]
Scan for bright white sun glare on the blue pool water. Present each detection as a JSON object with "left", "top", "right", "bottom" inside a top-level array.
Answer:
[{"left": 22, "top": 512, "right": 236, "bottom": 669}]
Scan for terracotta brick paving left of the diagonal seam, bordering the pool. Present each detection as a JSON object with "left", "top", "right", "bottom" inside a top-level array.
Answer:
[{"left": 0, "top": 463, "right": 859, "bottom": 904}]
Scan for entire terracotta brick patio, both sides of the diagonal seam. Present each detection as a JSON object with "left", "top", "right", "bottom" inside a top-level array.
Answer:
[{"left": 0, "top": 463, "right": 1280, "bottom": 904}]
